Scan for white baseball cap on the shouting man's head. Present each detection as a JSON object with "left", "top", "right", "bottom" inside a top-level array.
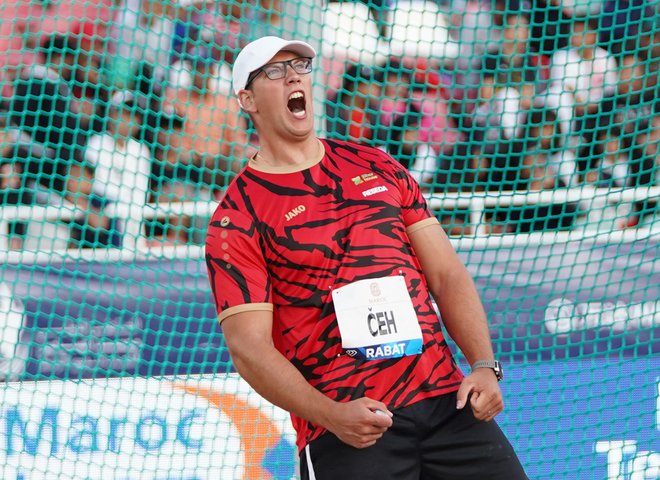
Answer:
[{"left": 232, "top": 36, "right": 316, "bottom": 95}]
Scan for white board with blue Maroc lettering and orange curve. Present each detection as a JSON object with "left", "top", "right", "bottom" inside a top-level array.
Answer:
[{"left": 0, "top": 375, "right": 297, "bottom": 480}]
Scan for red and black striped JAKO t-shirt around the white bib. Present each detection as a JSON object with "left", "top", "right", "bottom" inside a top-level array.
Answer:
[{"left": 206, "top": 140, "right": 463, "bottom": 449}]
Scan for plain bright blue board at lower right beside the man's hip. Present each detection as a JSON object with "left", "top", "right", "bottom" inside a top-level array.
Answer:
[{"left": 498, "top": 356, "right": 660, "bottom": 480}]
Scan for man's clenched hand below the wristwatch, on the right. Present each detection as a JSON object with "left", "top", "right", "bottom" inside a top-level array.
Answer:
[{"left": 456, "top": 368, "right": 504, "bottom": 422}]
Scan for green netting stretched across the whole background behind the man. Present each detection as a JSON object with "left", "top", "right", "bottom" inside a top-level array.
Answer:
[{"left": 0, "top": 0, "right": 660, "bottom": 480}]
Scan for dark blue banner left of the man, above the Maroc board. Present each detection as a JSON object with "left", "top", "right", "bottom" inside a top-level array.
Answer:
[{"left": 0, "top": 260, "right": 231, "bottom": 379}]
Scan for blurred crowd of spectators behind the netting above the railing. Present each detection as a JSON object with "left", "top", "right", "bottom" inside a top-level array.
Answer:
[{"left": 0, "top": 0, "right": 660, "bottom": 249}]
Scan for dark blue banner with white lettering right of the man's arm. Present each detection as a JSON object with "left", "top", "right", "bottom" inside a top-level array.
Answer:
[{"left": 458, "top": 237, "right": 660, "bottom": 362}]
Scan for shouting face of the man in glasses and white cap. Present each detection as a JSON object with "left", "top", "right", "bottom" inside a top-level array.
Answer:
[{"left": 248, "top": 51, "right": 314, "bottom": 137}]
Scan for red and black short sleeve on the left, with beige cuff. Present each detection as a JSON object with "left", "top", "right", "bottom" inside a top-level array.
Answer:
[{"left": 206, "top": 207, "right": 273, "bottom": 322}]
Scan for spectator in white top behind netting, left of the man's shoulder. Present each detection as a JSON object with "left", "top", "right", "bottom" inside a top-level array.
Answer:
[{"left": 79, "top": 91, "right": 151, "bottom": 247}]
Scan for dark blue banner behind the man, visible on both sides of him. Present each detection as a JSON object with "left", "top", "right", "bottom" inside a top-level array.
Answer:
[{"left": 0, "top": 240, "right": 660, "bottom": 379}]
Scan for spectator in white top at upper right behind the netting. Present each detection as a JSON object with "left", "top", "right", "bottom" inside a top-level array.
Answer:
[{"left": 548, "top": 10, "right": 617, "bottom": 183}]
